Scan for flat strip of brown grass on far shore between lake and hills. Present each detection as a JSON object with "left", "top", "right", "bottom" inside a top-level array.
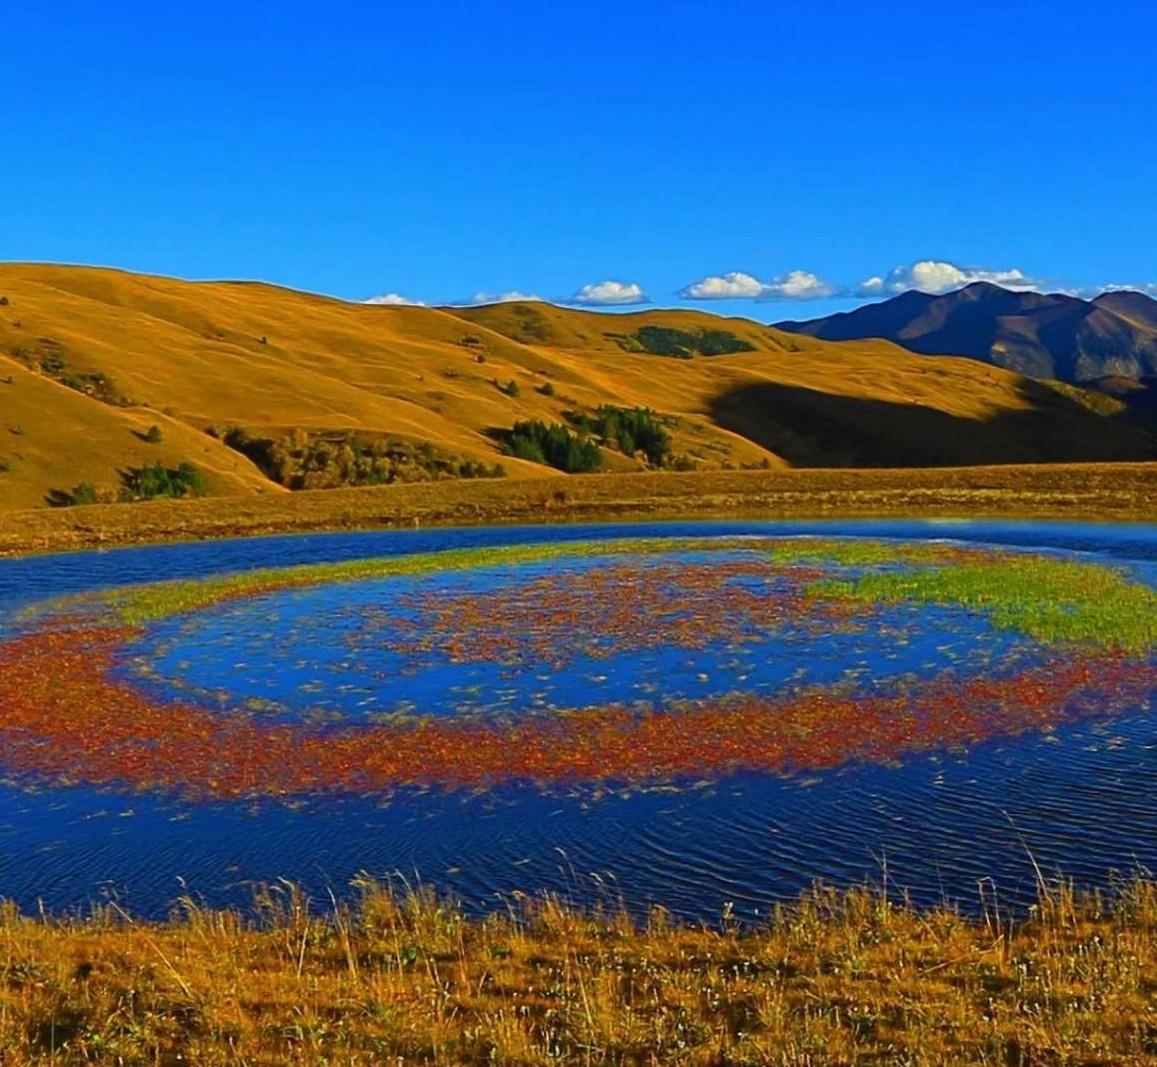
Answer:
[{"left": 0, "top": 464, "right": 1157, "bottom": 555}]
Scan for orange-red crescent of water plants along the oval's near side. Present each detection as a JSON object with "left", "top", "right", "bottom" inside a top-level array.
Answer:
[{"left": 0, "top": 627, "right": 1157, "bottom": 799}]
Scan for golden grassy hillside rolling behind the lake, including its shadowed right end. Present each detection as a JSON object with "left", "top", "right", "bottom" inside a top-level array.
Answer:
[{"left": 0, "top": 264, "right": 1157, "bottom": 508}]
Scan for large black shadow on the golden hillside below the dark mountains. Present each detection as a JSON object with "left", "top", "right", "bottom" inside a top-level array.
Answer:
[{"left": 712, "top": 380, "right": 1157, "bottom": 468}]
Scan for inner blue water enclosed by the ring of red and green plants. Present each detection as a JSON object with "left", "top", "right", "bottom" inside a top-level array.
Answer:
[{"left": 125, "top": 551, "right": 1037, "bottom": 721}]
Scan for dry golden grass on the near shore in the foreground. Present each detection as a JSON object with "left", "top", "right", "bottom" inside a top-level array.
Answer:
[{"left": 0, "top": 881, "right": 1157, "bottom": 1067}]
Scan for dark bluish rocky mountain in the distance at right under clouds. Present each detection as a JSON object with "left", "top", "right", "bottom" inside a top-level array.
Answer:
[{"left": 778, "top": 281, "right": 1157, "bottom": 384}]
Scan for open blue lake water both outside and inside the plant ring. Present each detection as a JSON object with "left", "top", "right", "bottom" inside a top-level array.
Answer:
[{"left": 0, "top": 522, "right": 1157, "bottom": 919}]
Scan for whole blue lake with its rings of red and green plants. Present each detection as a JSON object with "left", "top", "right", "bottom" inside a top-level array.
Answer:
[{"left": 0, "top": 521, "right": 1157, "bottom": 920}]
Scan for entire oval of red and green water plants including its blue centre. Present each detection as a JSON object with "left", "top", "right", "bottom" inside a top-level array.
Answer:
[{"left": 0, "top": 537, "right": 1157, "bottom": 797}]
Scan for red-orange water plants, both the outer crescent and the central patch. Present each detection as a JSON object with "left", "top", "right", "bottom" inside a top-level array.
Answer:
[{"left": 0, "top": 543, "right": 1157, "bottom": 799}]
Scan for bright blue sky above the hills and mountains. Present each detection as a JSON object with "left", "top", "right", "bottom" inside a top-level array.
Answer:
[{"left": 0, "top": 0, "right": 1157, "bottom": 321}]
